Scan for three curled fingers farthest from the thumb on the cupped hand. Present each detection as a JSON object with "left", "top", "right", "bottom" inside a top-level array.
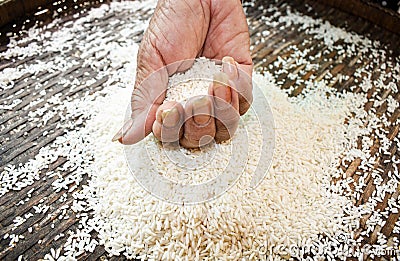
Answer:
[{"left": 180, "top": 57, "right": 248, "bottom": 148}]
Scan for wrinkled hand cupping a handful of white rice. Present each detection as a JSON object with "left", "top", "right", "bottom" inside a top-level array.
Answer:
[{"left": 113, "top": 0, "right": 252, "bottom": 148}]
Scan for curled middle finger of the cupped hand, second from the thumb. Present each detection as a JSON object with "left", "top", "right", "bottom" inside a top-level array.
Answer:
[{"left": 180, "top": 96, "right": 216, "bottom": 148}]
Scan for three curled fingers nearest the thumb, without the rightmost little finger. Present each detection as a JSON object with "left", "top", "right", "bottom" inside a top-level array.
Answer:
[{"left": 142, "top": 65, "right": 245, "bottom": 148}]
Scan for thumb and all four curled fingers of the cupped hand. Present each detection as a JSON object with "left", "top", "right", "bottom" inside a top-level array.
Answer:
[{"left": 113, "top": 57, "right": 253, "bottom": 148}]
